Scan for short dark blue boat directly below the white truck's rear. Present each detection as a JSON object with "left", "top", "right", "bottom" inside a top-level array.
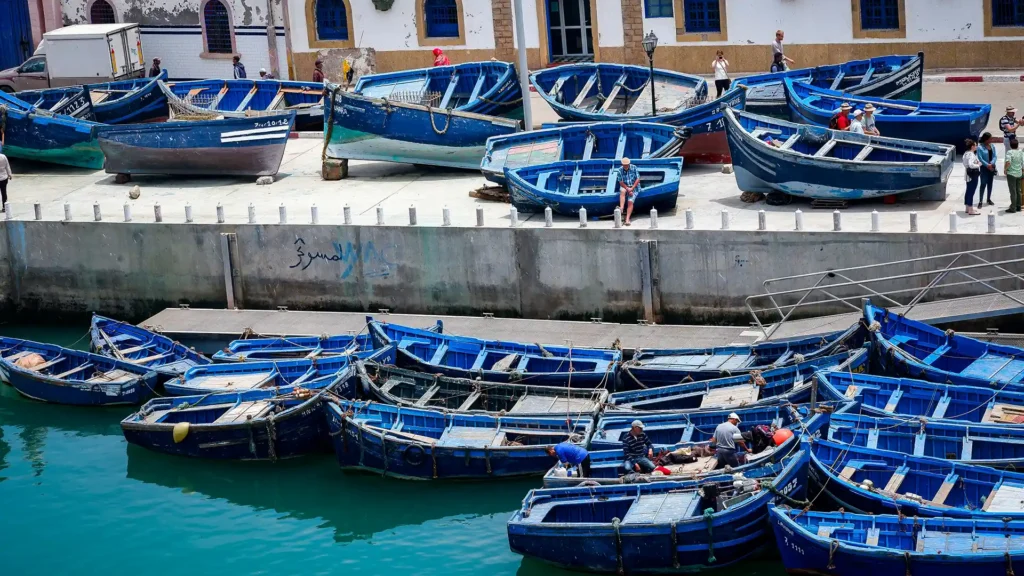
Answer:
[{"left": 84, "top": 70, "right": 168, "bottom": 124}]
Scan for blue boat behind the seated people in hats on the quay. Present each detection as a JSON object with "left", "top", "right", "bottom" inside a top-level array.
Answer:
[{"left": 784, "top": 78, "right": 992, "bottom": 151}]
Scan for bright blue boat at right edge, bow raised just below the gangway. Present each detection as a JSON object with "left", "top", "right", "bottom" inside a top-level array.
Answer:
[{"left": 864, "top": 303, "right": 1024, "bottom": 388}]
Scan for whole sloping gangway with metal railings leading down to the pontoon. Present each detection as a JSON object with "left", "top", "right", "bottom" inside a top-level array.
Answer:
[{"left": 744, "top": 244, "right": 1024, "bottom": 340}]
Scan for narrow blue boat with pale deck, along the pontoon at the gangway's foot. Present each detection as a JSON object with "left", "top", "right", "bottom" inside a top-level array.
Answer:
[{"left": 618, "top": 325, "right": 865, "bottom": 389}]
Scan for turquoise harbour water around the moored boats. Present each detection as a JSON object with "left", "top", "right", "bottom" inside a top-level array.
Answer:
[{"left": 0, "top": 326, "right": 783, "bottom": 576}]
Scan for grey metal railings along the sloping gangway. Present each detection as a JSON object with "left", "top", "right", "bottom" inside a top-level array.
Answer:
[{"left": 744, "top": 244, "right": 1024, "bottom": 339}]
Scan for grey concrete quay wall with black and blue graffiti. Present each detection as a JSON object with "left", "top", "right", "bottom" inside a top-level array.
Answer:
[{"left": 0, "top": 220, "right": 1019, "bottom": 323}]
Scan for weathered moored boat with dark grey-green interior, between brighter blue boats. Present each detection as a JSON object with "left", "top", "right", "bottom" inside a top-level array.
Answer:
[{"left": 355, "top": 360, "right": 608, "bottom": 416}]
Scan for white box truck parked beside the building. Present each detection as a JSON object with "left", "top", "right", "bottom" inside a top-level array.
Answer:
[{"left": 0, "top": 24, "right": 145, "bottom": 92}]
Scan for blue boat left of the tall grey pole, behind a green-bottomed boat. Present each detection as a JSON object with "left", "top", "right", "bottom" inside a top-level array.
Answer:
[{"left": 354, "top": 61, "right": 522, "bottom": 118}]
